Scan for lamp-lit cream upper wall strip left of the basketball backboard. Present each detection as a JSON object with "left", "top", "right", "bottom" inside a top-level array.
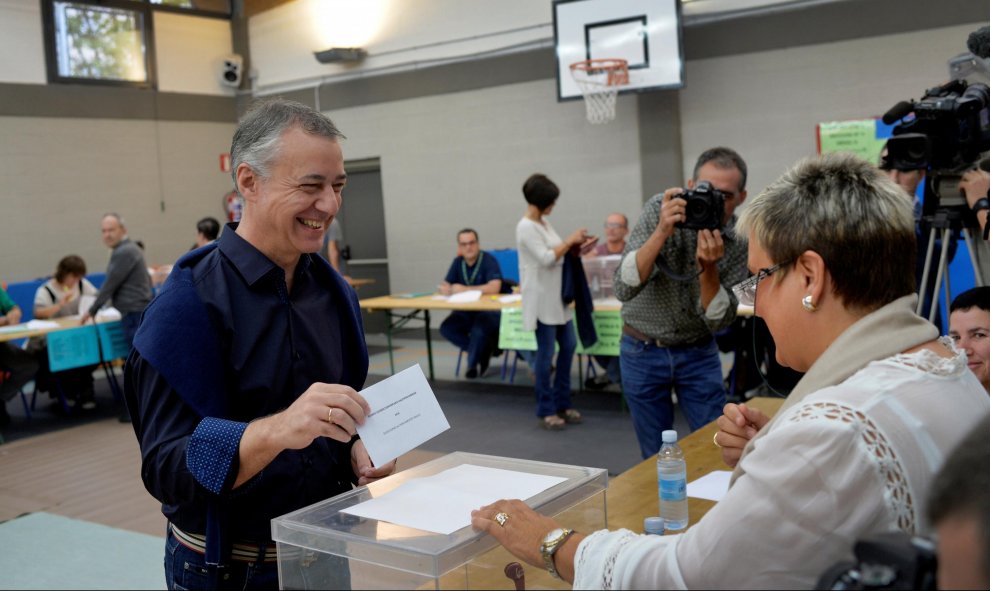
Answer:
[{"left": 248, "top": 0, "right": 553, "bottom": 93}]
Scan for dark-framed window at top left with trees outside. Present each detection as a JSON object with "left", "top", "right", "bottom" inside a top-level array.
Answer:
[{"left": 42, "top": 0, "right": 230, "bottom": 87}]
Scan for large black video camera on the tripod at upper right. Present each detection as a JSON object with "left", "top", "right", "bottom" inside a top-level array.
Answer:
[{"left": 881, "top": 27, "right": 990, "bottom": 220}]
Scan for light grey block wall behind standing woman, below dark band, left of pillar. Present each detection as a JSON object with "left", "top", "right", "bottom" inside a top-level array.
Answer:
[{"left": 328, "top": 80, "right": 642, "bottom": 292}]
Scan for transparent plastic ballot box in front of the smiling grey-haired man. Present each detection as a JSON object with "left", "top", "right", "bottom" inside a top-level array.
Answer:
[{"left": 272, "top": 452, "right": 608, "bottom": 589}]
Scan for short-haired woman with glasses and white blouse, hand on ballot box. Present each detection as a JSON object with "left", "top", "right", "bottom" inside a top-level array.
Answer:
[{"left": 472, "top": 155, "right": 990, "bottom": 589}]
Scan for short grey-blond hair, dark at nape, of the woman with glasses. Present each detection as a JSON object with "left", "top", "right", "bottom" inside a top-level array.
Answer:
[{"left": 738, "top": 154, "right": 917, "bottom": 310}]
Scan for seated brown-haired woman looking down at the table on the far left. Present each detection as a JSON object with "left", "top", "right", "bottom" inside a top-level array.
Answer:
[{"left": 27, "top": 255, "right": 97, "bottom": 410}]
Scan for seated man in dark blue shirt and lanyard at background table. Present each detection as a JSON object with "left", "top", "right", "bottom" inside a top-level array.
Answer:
[{"left": 440, "top": 228, "right": 502, "bottom": 378}]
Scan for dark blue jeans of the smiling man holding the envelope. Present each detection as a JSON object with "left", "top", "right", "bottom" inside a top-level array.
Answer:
[{"left": 165, "top": 530, "right": 351, "bottom": 591}]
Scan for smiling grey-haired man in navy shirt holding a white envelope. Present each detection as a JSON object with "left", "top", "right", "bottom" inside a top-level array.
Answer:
[{"left": 125, "top": 100, "right": 395, "bottom": 589}]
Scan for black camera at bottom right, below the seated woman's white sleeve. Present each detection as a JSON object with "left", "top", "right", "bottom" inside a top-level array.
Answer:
[{"left": 815, "top": 532, "right": 938, "bottom": 591}]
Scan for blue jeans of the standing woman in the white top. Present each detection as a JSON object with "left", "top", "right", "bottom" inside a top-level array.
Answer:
[{"left": 533, "top": 320, "right": 577, "bottom": 417}]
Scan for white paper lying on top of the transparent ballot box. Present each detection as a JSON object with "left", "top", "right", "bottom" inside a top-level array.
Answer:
[{"left": 342, "top": 464, "right": 567, "bottom": 534}]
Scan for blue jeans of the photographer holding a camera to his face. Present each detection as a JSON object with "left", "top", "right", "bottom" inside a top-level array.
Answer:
[{"left": 619, "top": 335, "right": 725, "bottom": 459}]
